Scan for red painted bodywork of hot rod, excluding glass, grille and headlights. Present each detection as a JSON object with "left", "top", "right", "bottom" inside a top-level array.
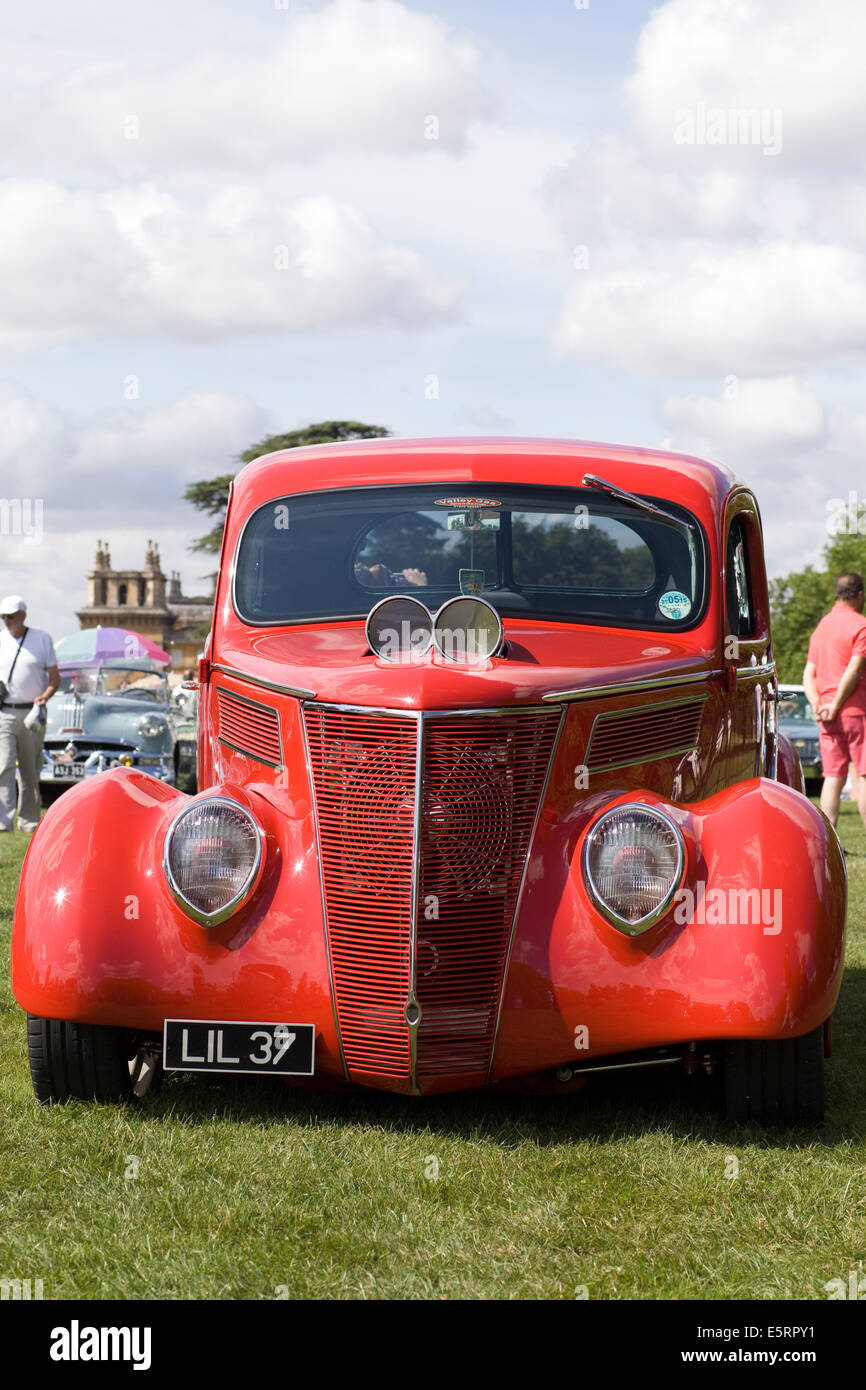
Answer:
[{"left": 13, "top": 439, "right": 847, "bottom": 1093}]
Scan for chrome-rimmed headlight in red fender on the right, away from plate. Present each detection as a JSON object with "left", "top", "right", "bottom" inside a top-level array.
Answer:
[{"left": 584, "top": 803, "right": 685, "bottom": 937}]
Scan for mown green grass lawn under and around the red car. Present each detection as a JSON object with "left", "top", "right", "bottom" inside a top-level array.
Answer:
[{"left": 0, "top": 805, "right": 866, "bottom": 1298}]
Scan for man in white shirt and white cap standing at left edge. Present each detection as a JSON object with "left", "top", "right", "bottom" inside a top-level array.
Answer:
[{"left": 0, "top": 594, "right": 60, "bottom": 835}]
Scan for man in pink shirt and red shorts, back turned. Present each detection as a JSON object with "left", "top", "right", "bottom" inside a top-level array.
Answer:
[{"left": 803, "top": 573, "right": 866, "bottom": 826}]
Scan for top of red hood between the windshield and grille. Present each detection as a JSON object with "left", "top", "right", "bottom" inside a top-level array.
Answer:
[{"left": 213, "top": 619, "right": 716, "bottom": 709}]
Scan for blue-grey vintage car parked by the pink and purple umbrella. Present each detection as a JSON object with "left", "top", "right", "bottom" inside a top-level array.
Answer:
[{"left": 39, "top": 657, "right": 179, "bottom": 790}]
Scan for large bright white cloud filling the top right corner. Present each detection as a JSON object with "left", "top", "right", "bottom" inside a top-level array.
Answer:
[{"left": 546, "top": 0, "right": 866, "bottom": 377}]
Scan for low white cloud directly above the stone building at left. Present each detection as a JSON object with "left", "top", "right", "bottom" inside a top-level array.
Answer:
[{"left": 0, "top": 382, "right": 274, "bottom": 637}]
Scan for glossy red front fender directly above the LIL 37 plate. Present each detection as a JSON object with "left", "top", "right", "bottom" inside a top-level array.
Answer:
[{"left": 13, "top": 769, "right": 342, "bottom": 1074}]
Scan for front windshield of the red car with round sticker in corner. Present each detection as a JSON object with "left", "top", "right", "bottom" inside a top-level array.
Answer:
[{"left": 235, "top": 484, "right": 705, "bottom": 630}]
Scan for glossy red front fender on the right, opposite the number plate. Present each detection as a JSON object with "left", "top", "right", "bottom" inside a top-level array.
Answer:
[{"left": 493, "top": 778, "right": 847, "bottom": 1077}]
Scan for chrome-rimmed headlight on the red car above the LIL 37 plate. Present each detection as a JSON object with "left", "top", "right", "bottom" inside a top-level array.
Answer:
[{"left": 163, "top": 796, "right": 264, "bottom": 927}]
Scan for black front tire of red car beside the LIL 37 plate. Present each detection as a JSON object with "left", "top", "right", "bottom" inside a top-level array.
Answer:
[{"left": 26, "top": 1013, "right": 135, "bottom": 1105}]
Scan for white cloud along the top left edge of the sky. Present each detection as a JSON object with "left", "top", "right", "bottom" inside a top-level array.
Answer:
[{"left": 0, "top": 0, "right": 489, "bottom": 178}]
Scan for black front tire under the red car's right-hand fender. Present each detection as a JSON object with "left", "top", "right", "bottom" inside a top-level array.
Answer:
[{"left": 724, "top": 1024, "right": 824, "bottom": 1126}]
